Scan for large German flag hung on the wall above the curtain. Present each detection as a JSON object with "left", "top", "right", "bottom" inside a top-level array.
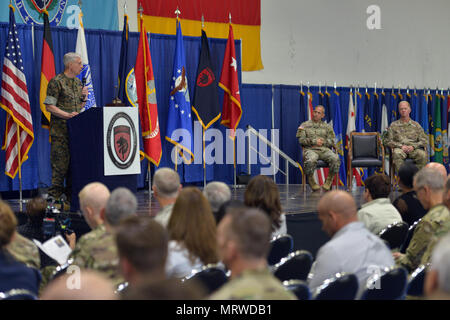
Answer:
[{"left": 138, "top": 0, "right": 264, "bottom": 71}]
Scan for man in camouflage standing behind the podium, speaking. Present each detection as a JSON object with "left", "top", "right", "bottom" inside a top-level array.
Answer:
[{"left": 44, "top": 52, "right": 88, "bottom": 202}]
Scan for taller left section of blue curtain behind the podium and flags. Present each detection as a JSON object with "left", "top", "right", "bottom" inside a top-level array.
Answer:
[{"left": 0, "top": 23, "right": 247, "bottom": 191}]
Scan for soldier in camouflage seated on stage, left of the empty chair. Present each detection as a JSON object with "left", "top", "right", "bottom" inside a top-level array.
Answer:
[{"left": 296, "top": 105, "right": 341, "bottom": 191}]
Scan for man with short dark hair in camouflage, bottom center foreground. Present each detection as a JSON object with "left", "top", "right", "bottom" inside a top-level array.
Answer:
[{"left": 210, "top": 207, "right": 296, "bottom": 300}]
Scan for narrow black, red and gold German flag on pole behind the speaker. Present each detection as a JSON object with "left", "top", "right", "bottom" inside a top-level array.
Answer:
[{"left": 39, "top": 10, "right": 55, "bottom": 129}]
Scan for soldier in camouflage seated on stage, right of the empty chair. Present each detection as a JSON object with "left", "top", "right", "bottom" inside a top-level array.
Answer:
[{"left": 384, "top": 101, "right": 428, "bottom": 172}]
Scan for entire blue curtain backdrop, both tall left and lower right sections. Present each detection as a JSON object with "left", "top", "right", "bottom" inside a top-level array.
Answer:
[{"left": 0, "top": 23, "right": 446, "bottom": 191}]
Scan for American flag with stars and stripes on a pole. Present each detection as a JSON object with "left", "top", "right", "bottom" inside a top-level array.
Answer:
[{"left": 0, "top": 5, "right": 34, "bottom": 179}]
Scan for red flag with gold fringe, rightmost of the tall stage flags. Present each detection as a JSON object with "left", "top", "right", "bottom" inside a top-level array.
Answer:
[{"left": 219, "top": 24, "right": 242, "bottom": 139}]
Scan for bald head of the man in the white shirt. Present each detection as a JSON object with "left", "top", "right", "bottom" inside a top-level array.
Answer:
[{"left": 317, "top": 191, "right": 358, "bottom": 237}]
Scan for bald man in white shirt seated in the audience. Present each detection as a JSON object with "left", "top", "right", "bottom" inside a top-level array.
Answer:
[{"left": 308, "top": 191, "right": 394, "bottom": 297}]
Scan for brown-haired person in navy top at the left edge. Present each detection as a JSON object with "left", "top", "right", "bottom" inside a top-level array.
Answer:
[{"left": 0, "top": 200, "right": 41, "bottom": 296}]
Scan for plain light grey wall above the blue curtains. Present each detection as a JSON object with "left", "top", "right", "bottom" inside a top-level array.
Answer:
[{"left": 119, "top": 0, "right": 450, "bottom": 88}]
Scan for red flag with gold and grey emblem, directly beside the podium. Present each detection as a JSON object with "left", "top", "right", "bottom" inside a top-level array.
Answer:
[{"left": 134, "top": 17, "right": 162, "bottom": 166}]
